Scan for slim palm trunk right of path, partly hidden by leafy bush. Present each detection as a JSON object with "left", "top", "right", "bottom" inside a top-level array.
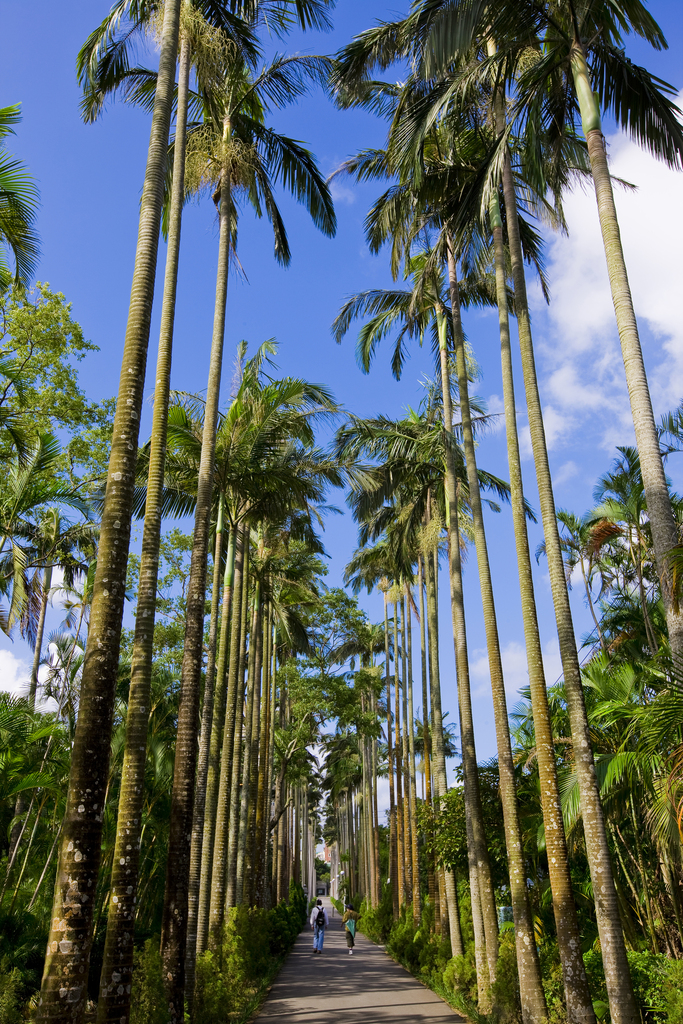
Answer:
[{"left": 427, "top": 550, "right": 465, "bottom": 956}]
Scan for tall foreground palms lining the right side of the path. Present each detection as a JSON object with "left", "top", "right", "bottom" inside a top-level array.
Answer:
[{"left": 323, "top": 0, "right": 683, "bottom": 1024}]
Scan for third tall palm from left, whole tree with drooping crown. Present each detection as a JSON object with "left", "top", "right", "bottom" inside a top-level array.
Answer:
[{"left": 157, "top": 44, "right": 335, "bottom": 1021}]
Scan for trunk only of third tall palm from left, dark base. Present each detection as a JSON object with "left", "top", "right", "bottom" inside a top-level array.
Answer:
[{"left": 161, "top": 132, "right": 230, "bottom": 1024}]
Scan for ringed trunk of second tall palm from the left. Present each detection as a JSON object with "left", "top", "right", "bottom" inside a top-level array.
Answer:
[{"left": 97, "top": 34, "right": 190, "bottom": 1024}]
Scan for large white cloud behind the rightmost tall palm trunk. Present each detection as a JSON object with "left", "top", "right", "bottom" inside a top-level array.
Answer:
[{"left": 522, "top": 93, "right": 683, "bottom": 457}]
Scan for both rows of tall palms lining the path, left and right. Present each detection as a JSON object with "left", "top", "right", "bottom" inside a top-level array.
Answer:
[{"left": 6, "top": 0, "right": 683, "bottom": 1024}]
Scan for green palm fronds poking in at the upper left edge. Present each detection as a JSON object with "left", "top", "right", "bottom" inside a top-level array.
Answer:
[{"left": 0, "top": 103, "right": 39, "bottom": 293}]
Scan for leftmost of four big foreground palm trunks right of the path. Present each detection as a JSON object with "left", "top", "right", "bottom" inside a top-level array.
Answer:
[{"left": 438, "top": 314, "right": 498, "bottom": 974}]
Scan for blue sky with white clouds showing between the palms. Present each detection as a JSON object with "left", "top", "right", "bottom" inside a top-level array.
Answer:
[{"left": 0, "top": 0, "right": 683, "bottom": 770}]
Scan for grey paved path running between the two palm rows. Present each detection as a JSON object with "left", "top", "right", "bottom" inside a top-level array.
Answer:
[{"left": 257, "top": 898, "right": 463, "bottom": 1024}]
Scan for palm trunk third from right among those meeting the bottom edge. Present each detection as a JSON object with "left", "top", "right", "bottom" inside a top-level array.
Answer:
[{"left": 447, "top": 249, "right": 548, "bottom": 1024}]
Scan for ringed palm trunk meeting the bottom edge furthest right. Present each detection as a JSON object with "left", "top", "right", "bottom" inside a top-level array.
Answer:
[{"left": 496, "top": 79, "right": 638, "bottom": 1024}]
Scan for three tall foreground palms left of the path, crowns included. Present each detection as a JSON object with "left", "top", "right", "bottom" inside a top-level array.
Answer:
[{"left": 39, "top": 0, "right": 335, "bottom": 1021}]
